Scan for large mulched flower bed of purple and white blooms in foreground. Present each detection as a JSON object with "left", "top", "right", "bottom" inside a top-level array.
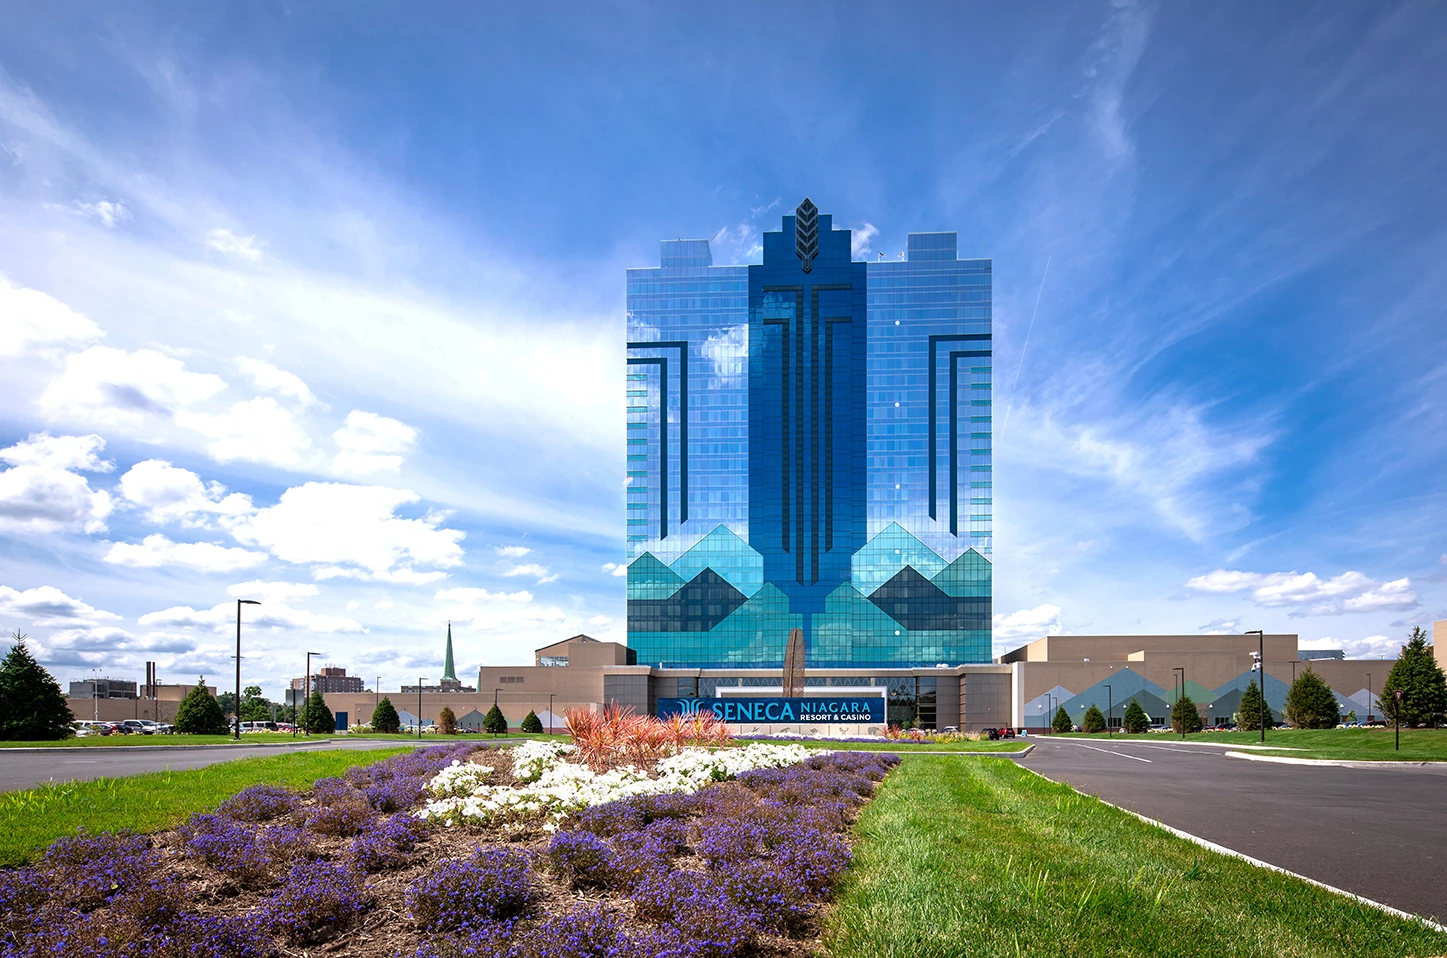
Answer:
[{"left": 0, "top": 742, "right": 897, "bottom": 958}]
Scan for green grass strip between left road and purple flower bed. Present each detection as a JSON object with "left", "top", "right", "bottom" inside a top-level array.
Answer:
[{"left": 0, "top": 748, "right": 405, "bottom": 865}]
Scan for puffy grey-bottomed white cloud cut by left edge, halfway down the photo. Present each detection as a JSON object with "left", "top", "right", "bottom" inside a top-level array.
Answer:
[{"left": 0, "top": 433, "right": 113, "bottom": 533}]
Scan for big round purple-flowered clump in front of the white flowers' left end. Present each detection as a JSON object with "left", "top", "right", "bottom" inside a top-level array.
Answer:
[{"left": 407, "top": 847, "right": 537, "bottom": 932}]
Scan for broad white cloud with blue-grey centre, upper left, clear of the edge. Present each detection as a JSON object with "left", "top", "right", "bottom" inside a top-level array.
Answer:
[{"left": 39, "top": 346, "right": 226, "bottom": 438}]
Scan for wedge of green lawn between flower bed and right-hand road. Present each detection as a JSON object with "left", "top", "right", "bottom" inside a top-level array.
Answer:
[{"left": 825, "top": 757, "right": 1447, "bottom": 958}]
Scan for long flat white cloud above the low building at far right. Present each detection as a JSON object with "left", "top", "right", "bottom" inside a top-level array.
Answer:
[{"left": 1185, "top": 569, "right": 1421, "bottom": 618}]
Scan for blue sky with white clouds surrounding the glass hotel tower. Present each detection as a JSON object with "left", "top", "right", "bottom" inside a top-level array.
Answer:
[{"left": 0, "top": 3, "right": 1447, "bottom": 695}]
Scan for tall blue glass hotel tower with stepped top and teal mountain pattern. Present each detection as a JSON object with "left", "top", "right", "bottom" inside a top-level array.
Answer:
[{"left": 627, "top": 200, "right": 993, "bottom": 669}]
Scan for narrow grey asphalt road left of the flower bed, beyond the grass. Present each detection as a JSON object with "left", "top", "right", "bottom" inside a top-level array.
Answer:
[{"left": 0, "top": 738, "right": 422, "bottom": 792}]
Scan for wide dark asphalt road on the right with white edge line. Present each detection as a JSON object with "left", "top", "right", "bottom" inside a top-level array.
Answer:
[{"left": 1020, "top": 735, "right": 1447, "bottom": 922}]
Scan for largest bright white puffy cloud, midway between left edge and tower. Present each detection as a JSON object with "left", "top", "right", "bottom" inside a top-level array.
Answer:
[{"left": 232, "top": 482, "right": 464, "bottom": 577}]
